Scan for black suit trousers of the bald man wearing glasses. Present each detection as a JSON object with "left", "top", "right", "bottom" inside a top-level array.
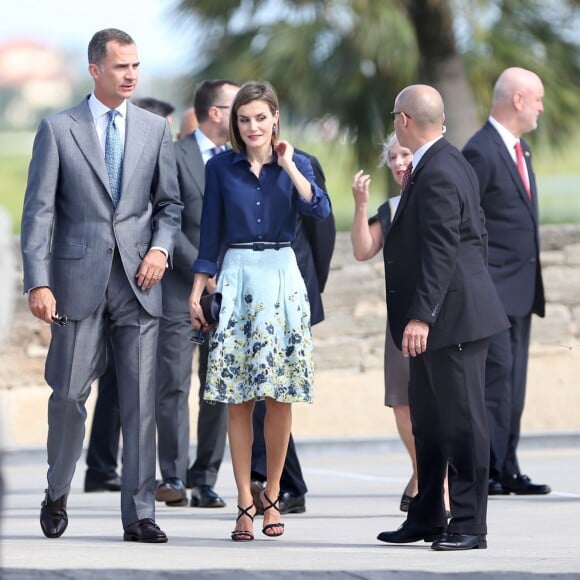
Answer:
[{"left": 408, "top": 338, "right": 489, "bottom": 534}]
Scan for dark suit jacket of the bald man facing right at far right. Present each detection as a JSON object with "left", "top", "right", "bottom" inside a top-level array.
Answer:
[{"left": 463, "top": 122, "right": 545, "bottom": 316}]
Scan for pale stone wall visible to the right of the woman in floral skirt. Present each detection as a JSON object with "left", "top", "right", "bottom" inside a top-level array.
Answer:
[{"left": 314, "top": 225, "right": 580, "bottom": 372}]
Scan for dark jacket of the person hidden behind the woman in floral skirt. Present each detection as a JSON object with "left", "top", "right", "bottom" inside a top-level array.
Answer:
[{"left": 292, "top": 150, "right": 336, "bottom": 324}]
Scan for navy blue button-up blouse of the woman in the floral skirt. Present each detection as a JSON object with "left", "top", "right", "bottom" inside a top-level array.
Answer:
[{"left": 192, "top": 150, "right": 330, "bottom": 276}]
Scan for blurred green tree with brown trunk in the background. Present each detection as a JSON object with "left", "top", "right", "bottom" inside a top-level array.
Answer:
[{"left": 178, "top": 0, "right": 580, "bottom": 165}]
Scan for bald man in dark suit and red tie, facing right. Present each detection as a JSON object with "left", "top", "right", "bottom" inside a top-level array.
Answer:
[{"left": 463, "top": 67, "right": 551, "bottom": 495}]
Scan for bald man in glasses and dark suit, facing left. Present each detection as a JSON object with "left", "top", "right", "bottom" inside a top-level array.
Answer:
[{"left": 378, "top": 85, "right": 508, "bottom": 550}]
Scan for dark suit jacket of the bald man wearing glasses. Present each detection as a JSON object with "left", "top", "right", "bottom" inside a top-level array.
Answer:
[{"left": 383, "top": 138, "right": 509, "bottom": 349}]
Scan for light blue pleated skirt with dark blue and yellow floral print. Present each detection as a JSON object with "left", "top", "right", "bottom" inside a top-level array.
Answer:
[{"left": 204, "top": 247, "right": 314, "bottom": 403}]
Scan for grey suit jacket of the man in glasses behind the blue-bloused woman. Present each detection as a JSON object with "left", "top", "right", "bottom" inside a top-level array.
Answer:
[{"left": 163, "top": 133, "right": 205, "bottom": 314}]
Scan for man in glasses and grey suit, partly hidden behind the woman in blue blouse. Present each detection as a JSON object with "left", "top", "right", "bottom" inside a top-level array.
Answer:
[{"left": 155, "top": 80, "right": 239, "bottom": 508}]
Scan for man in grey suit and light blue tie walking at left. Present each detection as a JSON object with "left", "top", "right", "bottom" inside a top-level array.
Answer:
[{"left": 21, "top": 29, "right": 182, "bottom": 542}]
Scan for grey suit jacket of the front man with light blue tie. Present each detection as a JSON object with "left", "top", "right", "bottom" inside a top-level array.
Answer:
[{"left": 21, "top": 99, "right": 182, "bottom": 320}]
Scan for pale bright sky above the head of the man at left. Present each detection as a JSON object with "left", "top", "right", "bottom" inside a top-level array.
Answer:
[{"left": 0, "top": 0, "right": 193, "bottom": 75}]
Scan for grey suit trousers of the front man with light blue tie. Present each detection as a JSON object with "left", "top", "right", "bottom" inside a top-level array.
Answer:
[{"left": 45, "top": 254, "right": 159, "bottom": 527}]
